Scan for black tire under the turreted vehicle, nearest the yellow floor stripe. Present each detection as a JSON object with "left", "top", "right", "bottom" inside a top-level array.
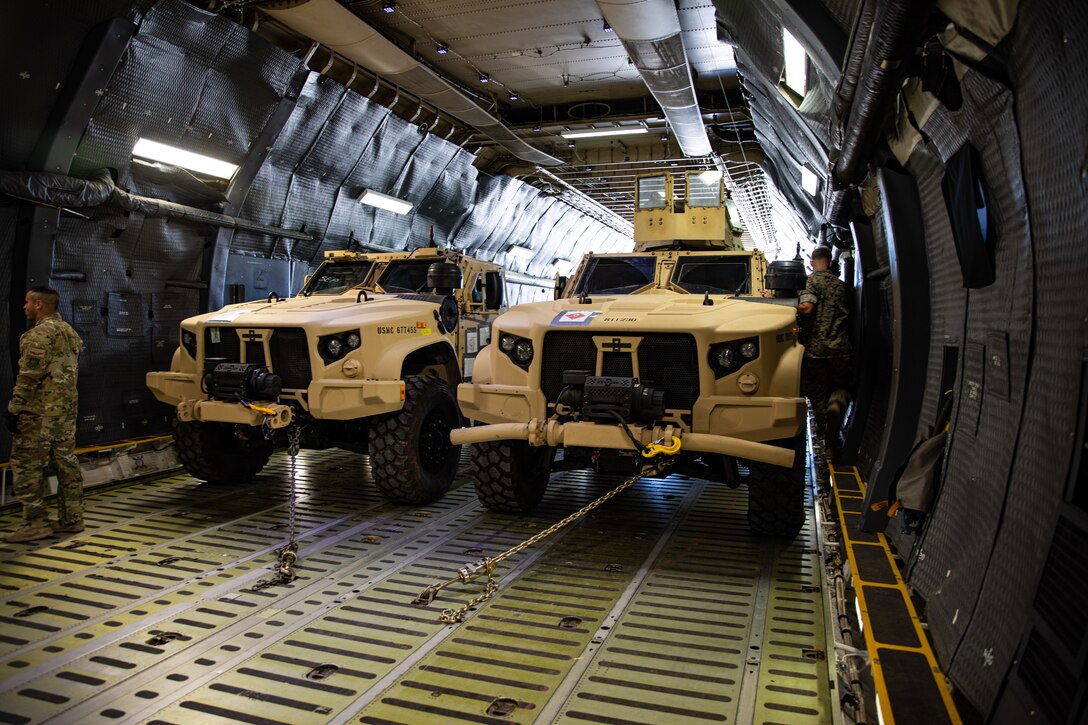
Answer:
[{"left": 747, "top": 435, "right": 808, "bottom": 538}]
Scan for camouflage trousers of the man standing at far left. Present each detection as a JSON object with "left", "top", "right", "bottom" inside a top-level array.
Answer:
[{"left": 11, "top": 413, "right": 83, "bottom": 525}]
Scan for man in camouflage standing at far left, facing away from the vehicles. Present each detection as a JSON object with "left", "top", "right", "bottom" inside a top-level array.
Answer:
[{"left": 3, "top": 287, "right": 83, "bottom": 542}]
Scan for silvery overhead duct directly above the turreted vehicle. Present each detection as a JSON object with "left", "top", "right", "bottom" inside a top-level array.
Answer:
[{"left": 597, "top": 0, "right": 710, "bottom": 157}]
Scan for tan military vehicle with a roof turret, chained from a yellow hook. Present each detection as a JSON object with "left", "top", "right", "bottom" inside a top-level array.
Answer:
[{"left": 452, "top": 172, "right": 806, "bottom": 536}]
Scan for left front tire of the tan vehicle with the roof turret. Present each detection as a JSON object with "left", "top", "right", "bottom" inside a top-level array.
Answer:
[{"left": 472, "top": 441, "right": 555, "bottom": 514}]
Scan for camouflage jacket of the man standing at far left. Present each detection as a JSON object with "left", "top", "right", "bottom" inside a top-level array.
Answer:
[{"left": 8, "top": 312, "right": 83, "bottom": 427}]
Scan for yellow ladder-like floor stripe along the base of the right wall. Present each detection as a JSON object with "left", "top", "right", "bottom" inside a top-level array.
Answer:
[{"left": 830, "top": 466, "right": 963, "bottom": 725}]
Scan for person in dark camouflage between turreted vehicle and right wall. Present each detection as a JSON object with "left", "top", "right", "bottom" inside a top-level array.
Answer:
[{"left": 798, "top": 247, "right": 852, "bottom": 454}]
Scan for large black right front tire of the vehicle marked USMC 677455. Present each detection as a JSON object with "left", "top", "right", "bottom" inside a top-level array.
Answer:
[{"left": 370, "top": 376, "right": 461, "bottom": 505}]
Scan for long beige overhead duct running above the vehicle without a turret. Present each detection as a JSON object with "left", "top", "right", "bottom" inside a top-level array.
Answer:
[{"left": 260, "top": 0, "right": 562, "bottom": 167}]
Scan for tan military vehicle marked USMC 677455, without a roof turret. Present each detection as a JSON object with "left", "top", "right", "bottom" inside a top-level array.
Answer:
[{"left": 147, "top": 248, "right": 504, "bottom": 504}]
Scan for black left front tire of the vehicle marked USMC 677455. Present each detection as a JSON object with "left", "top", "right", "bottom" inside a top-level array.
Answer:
[{"left": 174, "top": 418, "right": 272, "bottom": 483}]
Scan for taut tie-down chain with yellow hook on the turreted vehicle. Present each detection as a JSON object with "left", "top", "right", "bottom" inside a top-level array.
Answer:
[{"left": 411, "top": 435, "right": 680, "bottom": 624}]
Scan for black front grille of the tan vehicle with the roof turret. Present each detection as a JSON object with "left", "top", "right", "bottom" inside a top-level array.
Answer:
[{"left": 541, "top": 331, "right": 698, "bottom": 410}]
